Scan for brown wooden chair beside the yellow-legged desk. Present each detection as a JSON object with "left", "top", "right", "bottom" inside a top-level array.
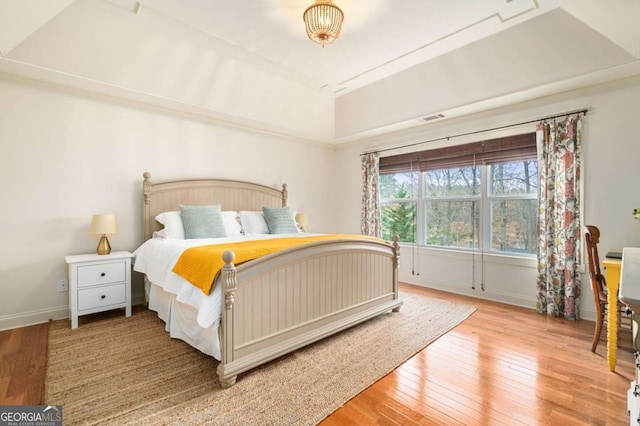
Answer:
[{"left": 584, "top": 225, "right": 629, "bottom": 352}]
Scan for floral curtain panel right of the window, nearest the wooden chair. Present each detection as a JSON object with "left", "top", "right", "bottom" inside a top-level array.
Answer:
[{"left": 536, "top": 114, "right": 583, "bottom": 320}]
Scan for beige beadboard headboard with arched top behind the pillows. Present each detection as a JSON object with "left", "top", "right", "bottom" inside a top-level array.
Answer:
[{"left": 142, "top": 172, "right": 287, "bottom": 241}]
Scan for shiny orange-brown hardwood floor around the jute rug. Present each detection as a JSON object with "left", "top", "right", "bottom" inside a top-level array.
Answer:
[{"left": 0, "top": 285, "right": 635, "bottom": 426}]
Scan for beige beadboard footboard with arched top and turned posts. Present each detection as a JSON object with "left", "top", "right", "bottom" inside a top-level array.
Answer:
[{"left": 218, "top": 239, "right": 402, "bottom": 387}]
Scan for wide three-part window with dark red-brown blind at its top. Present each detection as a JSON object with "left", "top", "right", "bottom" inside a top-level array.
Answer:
[{"left": 379, "top": 134, "right": 538, "bottom": 254}]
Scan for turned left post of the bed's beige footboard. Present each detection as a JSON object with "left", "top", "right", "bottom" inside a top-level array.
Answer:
[{"left": 217, "top": 250, "right": 237, "bottom": 388}]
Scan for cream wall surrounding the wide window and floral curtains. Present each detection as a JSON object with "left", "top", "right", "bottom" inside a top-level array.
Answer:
[{"left": 337, "top": 78, "right": 640, "bottom": 319}]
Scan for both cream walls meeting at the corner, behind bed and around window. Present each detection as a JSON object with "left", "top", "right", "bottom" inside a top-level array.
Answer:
[{"left": 5, "top": 70, "right": 640, "bottom": 329}]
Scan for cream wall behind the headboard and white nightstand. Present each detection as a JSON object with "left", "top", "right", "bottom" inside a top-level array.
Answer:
[{"left": 0, "top": 77, "right": 335, "bottom": 329}]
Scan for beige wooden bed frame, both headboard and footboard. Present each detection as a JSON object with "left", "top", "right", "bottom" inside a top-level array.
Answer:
[{"left": 142, "top": 172, "right": 402, "bottom": 387}]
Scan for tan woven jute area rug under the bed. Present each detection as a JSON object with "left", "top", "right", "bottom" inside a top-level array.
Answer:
[{"left": 45, "top": 293, "right": 475, "bottom": 425}]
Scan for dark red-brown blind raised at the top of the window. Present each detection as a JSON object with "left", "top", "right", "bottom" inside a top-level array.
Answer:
[{"left": 380, "top": 133, "right": 537, "bottom": 174}]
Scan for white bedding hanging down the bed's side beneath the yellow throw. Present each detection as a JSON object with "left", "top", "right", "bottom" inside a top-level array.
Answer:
[{"left": 133, "top": 233, "right": 315, "bottom": 360}]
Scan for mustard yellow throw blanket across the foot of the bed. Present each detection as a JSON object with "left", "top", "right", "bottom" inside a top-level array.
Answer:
[{"left": 173, "top": 234, "right": 383, "bottom": 294}]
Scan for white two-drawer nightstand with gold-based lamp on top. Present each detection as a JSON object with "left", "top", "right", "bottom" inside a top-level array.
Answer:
[{"left": 65, "top": 251, "right": 133, "bottom": 329}]
